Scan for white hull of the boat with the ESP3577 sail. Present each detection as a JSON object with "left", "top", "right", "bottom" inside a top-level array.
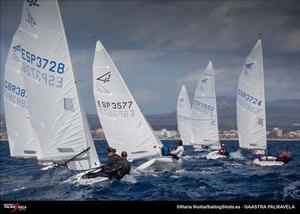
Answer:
[{"left": 136, "top": 156, "right": 182, "bottom": 171}]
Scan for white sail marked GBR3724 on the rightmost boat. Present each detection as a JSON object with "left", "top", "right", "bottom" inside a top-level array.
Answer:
[{"left": 236, "top": 39, "right": 266, "bottom": 150}]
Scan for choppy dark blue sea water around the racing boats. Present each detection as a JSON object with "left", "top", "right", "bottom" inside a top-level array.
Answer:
[{"left": 0, "top": 140, "right": 300, "bottom": 201}]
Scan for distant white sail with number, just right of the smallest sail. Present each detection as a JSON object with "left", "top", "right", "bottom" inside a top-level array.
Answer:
[{"left": 191, "top": 61, "right": 220, "bottom": 147}]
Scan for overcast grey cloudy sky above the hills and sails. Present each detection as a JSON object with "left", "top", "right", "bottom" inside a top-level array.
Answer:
[{"left": 0, "top": 0, "right": 300, "bottom": 114}]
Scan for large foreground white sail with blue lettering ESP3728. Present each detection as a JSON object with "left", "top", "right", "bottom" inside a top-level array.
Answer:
[{"left": 12, "top": 0, "right": 100, "bottom": 170}]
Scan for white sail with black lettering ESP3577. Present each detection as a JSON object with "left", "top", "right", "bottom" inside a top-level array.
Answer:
[{"left": 93, "top": 41, "right": 161, "bottom": 160}]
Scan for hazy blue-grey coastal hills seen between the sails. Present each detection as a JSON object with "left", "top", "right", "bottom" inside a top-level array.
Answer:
[{"left": 88, "top": 96, "right": 300, "bottom": 131}]
